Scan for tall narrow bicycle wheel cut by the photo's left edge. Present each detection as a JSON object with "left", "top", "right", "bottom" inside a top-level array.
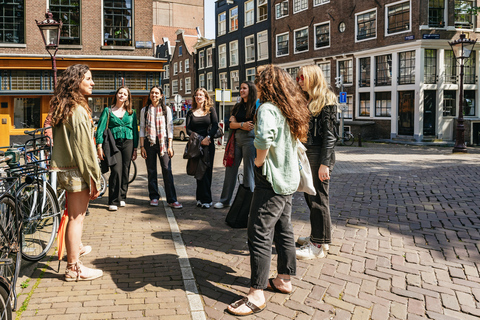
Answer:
[{"left": 0, "top": 194, "right": 22, "bottom": 312}]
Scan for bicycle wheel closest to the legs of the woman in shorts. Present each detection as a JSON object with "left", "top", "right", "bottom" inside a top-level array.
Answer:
[{"left": 16, "top": 179, "right": 60, "bottom": 261}]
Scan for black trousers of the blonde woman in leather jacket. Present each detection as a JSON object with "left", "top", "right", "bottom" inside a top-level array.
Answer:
[{"left": 305, "top": 149, "right": 335, "bottom": 244}]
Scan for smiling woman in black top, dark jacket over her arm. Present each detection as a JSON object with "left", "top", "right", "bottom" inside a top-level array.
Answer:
[{"left": 186, "top": 88, "right": 218, "bottom": 209}]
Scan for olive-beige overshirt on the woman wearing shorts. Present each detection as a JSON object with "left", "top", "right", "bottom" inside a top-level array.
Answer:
[{"left": 50, "top": 105, "right": 101, "bottom": 190}]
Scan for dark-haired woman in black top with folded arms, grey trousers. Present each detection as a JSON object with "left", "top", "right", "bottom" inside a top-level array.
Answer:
[{"left": 214, "top": 81, "right": 257, "bottom": 209}]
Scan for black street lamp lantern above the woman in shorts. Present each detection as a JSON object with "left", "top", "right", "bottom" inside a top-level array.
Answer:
[{"left": 35, "top": 10, "right": 62, "bottom": 88}]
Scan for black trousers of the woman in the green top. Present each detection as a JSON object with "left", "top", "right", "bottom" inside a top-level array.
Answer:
[{"left": 108, "top": 139, "right": 133, "bottom": 206}]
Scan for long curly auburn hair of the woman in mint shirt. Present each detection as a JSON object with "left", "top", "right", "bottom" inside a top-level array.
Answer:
[{"left": 255, "top": 64, "right": 310, "bottom": 142}]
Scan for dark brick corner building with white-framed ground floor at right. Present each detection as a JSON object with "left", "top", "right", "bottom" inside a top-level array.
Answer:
[{"left": 271, "top": 0, "right": 480, "bottom": 144}]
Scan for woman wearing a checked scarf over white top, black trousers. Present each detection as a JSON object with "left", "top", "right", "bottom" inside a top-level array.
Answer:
[{"left": 140, "top": 85, "right": 182, "bottom": 209}]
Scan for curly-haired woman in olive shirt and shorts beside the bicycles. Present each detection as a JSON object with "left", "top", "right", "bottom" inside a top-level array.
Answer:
[{"left": 50, "top": 64, "right": 103, "bottom": 281}]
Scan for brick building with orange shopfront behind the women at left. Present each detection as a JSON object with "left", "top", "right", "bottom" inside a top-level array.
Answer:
[{"left": 0, "top": 0, "right": 164, "bottom": 145}]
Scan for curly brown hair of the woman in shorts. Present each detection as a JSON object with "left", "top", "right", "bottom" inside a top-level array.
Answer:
[{"left": 50, "top": 64, "right": 91, "bottom": 127}]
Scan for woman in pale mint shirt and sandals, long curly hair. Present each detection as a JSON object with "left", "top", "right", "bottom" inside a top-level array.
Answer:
[{"left": 227, "top": 65, "right": 310, "bottom": 316}]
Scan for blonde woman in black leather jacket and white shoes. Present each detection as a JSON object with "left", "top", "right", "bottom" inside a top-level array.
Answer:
[{"left": 297, "top": 65, "right": 337, "bottom": 260}]
